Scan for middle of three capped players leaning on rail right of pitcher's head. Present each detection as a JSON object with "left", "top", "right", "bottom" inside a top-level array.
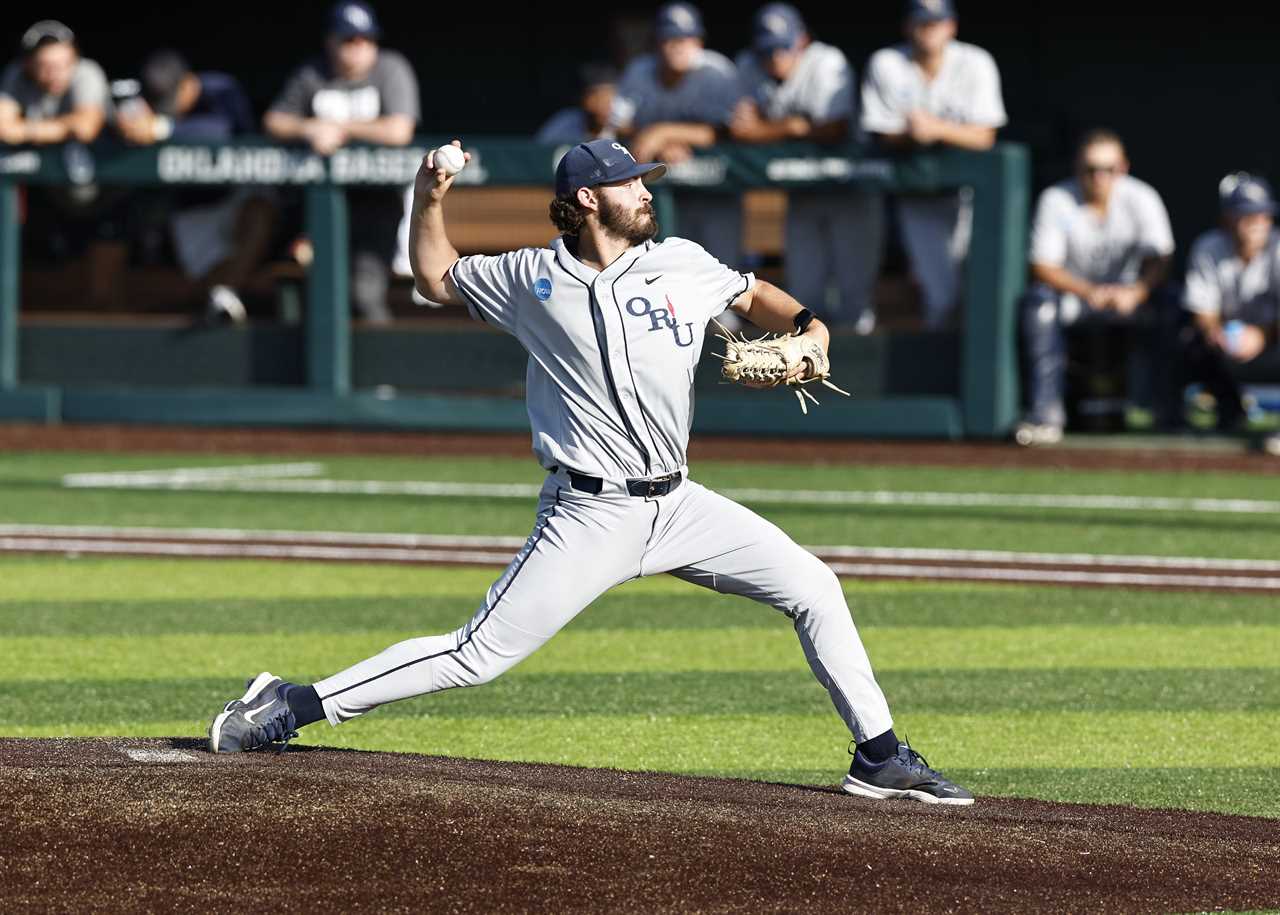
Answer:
[{"left": 730, "top": 3, "right": 884, "bottom": 334}]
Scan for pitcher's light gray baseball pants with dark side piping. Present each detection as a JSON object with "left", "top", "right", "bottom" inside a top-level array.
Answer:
[{"left": 315, "top": 471, "right": 892, "bottom": 742}]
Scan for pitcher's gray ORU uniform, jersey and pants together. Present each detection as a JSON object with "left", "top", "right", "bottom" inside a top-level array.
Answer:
[{"left": 315, "top": 230, "right": 892, "bottom": 741}]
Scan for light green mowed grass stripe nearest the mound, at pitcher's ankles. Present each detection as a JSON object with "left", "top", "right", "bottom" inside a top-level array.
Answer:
[{"left": 5, "top": 709, "right": 1280, "bottom": 772}]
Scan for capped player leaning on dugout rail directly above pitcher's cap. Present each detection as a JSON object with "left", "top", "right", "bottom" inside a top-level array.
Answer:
[{"left": 609, "top": 3, "right": 742, "bottom": 275}]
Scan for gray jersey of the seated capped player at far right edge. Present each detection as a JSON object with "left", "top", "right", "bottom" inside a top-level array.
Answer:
[{"left": 1183, "top": 229, "right": 1280, "bottom": 328}]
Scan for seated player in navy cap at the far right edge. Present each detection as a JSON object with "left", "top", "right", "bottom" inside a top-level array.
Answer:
[{"left": 1170, "top": 171, "right": 1280, "bottom": 450}]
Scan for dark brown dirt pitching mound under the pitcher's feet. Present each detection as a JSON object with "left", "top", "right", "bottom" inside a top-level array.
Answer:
[{"left": 0, "top": 738, "right": 1280, "bottom": 912}]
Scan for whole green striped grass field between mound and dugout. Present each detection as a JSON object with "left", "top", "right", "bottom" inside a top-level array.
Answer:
[{"left": 0, "top": 453, "right": 1280, "bottom": 816}]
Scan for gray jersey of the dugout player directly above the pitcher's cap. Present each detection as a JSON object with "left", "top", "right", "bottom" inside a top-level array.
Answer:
[{"left": 609, "top": 49, "right": 742, "bottom": 131}]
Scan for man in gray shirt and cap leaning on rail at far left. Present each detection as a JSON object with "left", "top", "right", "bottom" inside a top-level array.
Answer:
[{"left": 0, "top": 19, "right": 111, "bottom": 146}]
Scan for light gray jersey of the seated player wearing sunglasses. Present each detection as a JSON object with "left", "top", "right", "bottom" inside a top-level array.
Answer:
[{"left": 1030, "top": 175, "right": 1174, "bottom": 283}]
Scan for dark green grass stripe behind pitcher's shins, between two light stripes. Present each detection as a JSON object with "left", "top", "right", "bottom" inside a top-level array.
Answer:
[{"left": 0, "top": 668, "right": 1280, "bottom": 731}]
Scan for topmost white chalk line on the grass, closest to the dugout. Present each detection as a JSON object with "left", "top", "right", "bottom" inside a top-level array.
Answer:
[{"left": 63, "top": 463, "right": 1280, "bottom": 514}]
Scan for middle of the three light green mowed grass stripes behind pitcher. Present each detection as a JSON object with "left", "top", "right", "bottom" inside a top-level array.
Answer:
[{"left": 0, "top": 625, "right": 1280, "bottom": 681}]
